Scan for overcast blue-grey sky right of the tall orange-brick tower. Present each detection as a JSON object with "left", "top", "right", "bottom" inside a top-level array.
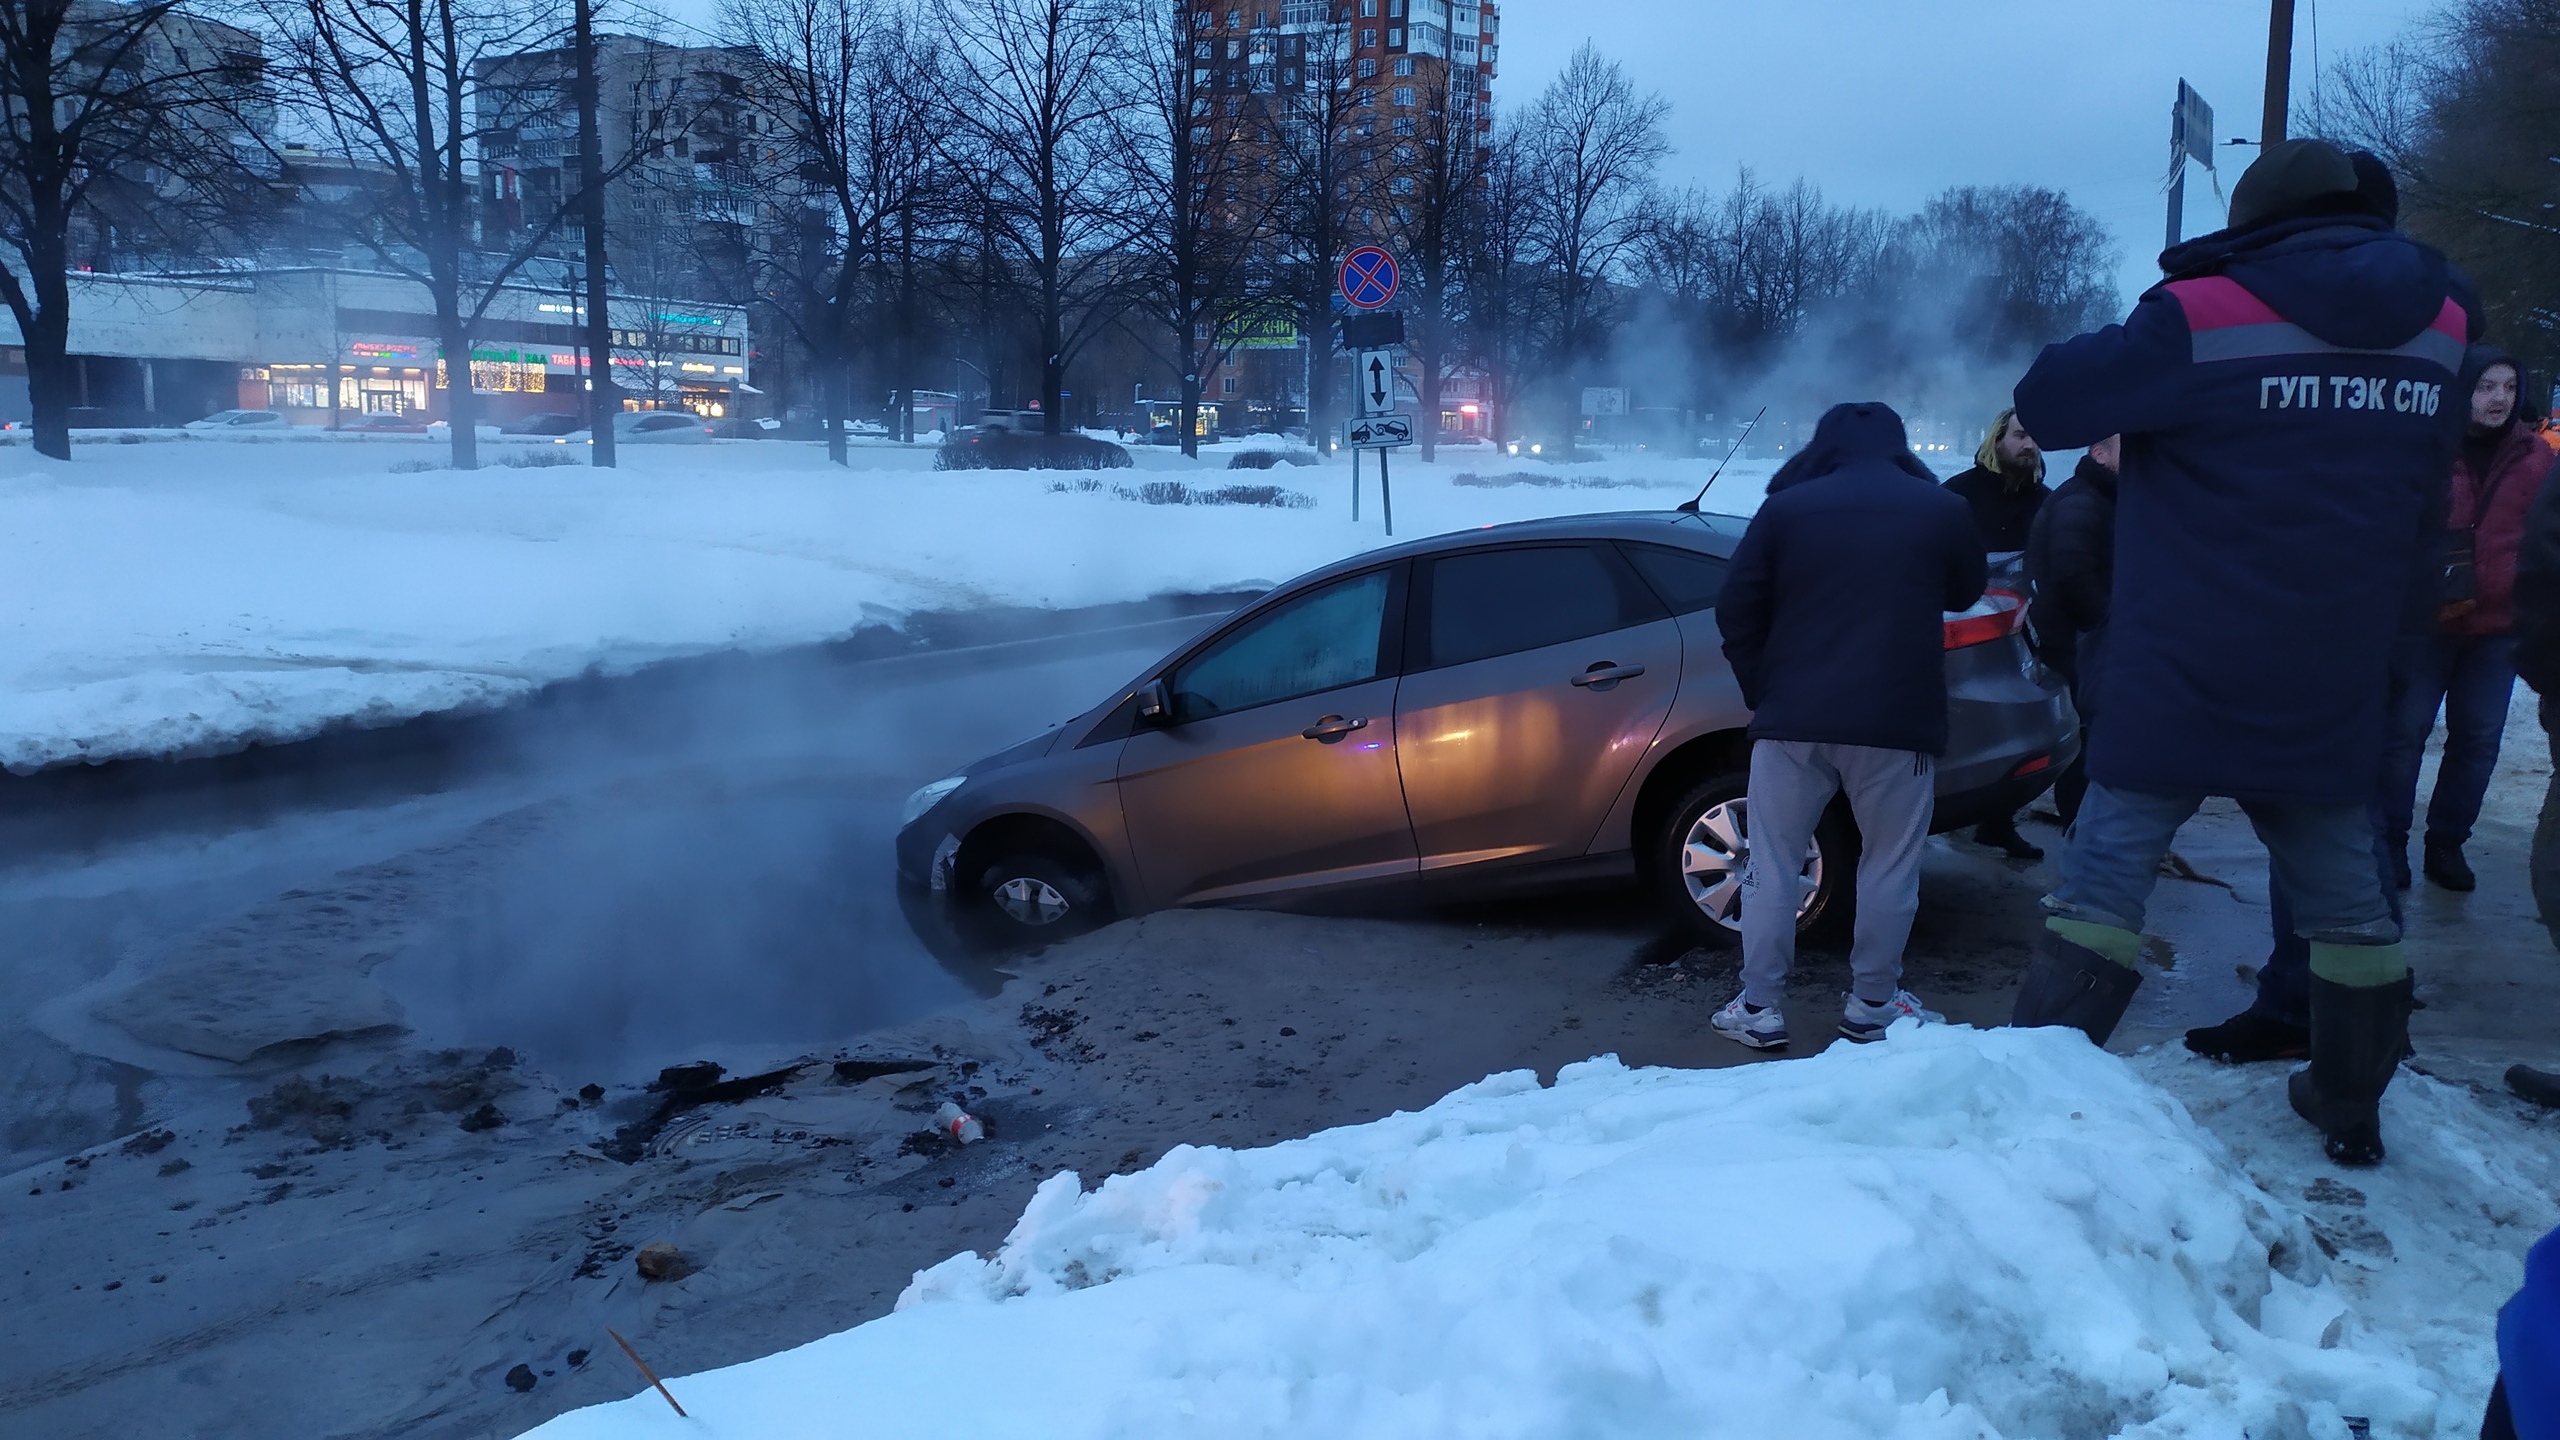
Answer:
[{"left": 1495, "top": 0, "right": 2435, "bottom": 302}]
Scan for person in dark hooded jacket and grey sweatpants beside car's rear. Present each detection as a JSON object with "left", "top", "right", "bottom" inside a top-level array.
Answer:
[{"left": 1713, "top": 405, "right": 1984, "bottom": 1051}]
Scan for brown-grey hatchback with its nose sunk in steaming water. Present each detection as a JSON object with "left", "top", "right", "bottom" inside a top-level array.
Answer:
[{"left": 896, "top": 512, "right": 2079, "bottom": 938}]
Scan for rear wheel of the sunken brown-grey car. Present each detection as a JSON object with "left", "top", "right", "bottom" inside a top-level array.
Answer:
[{"left": 1649, "top": 771, "right": 1859, "bottom": 945}]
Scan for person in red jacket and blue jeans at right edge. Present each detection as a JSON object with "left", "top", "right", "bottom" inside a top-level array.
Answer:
[{"left": 2381, "top": 346, "right": 2552, "bottom": 889}]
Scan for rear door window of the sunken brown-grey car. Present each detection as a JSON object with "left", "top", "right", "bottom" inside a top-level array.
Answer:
[{"left": 1423, "top": 546, "right": 1661, "bottom": 669}]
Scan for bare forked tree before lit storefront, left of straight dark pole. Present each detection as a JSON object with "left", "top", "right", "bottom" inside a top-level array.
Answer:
[{"left": 264, "top": 0, "right": 593, "bottom": 469}]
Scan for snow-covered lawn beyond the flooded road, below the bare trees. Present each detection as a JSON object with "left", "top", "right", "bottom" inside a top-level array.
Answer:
[{"left": 0, "top": 438, "right": 1772, "bottom": 771}]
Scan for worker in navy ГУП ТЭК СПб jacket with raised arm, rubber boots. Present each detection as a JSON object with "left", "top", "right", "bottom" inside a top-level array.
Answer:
[{"left": 2017, "top": 141, "right": 2473, "bottom": 1163}]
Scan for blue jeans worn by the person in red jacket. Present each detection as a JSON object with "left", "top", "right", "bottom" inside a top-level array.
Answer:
[{"left": 2383, "top": 635, "right": 2516, "bottom": 853}]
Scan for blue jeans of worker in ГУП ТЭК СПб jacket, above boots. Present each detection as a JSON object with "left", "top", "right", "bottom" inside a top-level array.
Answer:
[{"left": 2043, "top": 784, "right": 2399, "bottom": 945}]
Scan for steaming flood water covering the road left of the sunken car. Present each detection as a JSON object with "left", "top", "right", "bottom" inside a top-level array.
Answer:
[{"left": 0, "top": 597, "right": 1236, "bottom": 1174}]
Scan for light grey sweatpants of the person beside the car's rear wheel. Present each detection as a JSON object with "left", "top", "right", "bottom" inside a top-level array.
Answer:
[{"left": 1743, "top": 740, "right": 1938, "bottom": 1004}]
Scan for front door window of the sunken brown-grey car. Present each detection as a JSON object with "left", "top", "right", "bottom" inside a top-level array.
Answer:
[{"left": 1167, "top": 569, "right": 1388, "bottom": 725}]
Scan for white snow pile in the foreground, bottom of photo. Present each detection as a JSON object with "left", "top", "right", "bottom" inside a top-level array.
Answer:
[{"left": 535, "top": 1025, "right": 2478, "bottom": 1440}]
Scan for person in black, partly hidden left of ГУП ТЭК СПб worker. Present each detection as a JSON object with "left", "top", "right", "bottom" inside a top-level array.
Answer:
[{"left": 2028, "top": 436, "right": 2125, "bottom": 825}]
